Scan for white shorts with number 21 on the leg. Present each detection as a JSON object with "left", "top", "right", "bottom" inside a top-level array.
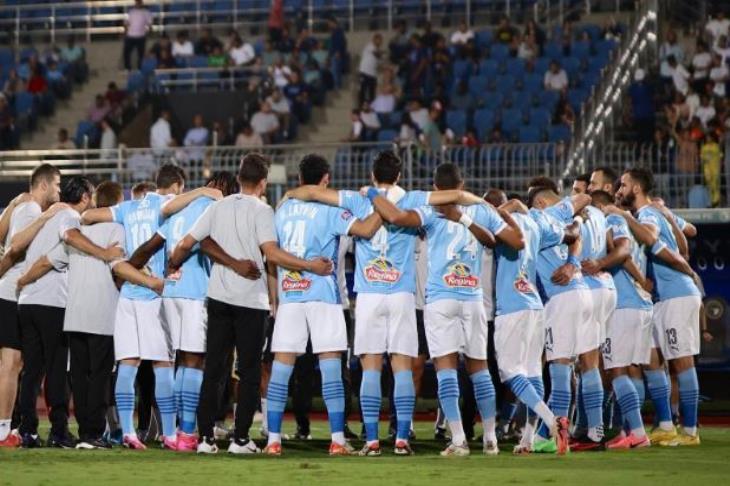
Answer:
[{"left": 545, "top": 289, "right": 601, "bottom": 361}]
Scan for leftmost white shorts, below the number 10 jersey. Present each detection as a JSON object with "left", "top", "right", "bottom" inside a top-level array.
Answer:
[{"left": 114, "top": 297, "right": 173, "bottom": 361}]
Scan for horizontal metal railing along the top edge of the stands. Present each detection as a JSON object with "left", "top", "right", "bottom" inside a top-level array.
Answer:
[{"left": 0, "top": 0, "right": 626, "bottom": 46}]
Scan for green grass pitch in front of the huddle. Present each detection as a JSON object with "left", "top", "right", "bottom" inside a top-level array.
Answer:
[{"left": 0, "top": 422, "right": 730, "bottom": 486}]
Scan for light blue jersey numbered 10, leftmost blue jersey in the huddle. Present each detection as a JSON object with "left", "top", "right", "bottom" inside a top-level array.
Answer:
[{"left": 109, "top": 192, "right": 169, "bottom": 300}]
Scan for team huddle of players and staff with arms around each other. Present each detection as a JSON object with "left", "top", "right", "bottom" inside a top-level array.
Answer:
[{"left": 0, "top": 151, "right": 701, "bottom": 456}]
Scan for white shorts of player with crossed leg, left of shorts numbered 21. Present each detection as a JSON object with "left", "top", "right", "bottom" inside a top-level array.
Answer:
[{"left": 494, "top": 310, "right": 545, "bottom": 383}]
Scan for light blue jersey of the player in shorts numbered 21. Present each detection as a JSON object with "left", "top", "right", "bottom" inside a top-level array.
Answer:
[{"left": 530, "top": 203, "right": 588, "bottom": 299}]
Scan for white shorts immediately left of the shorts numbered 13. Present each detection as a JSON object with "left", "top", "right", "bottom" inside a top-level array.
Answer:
[{"left": 601, "top": 309, "right": 652, "bottom": 370}]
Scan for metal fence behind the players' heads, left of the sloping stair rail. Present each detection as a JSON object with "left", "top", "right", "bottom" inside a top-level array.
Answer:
[{"left": 0, "top": 143, "right": 565, "bottom": 201}]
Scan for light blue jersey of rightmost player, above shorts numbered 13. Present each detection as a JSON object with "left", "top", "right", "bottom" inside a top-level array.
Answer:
[{"left": 636, "top": 206, "right": 700, "bottom": 301}]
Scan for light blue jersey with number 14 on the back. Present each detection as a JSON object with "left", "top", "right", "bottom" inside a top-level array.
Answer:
[{"left": 274, "top": 199, "right": 357, "bottom": 304}]
